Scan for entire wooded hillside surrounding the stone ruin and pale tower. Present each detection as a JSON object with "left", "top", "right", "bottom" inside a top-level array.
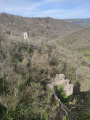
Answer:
[{"left": 0, "top": 14, "right": 90, "bottom": 120}]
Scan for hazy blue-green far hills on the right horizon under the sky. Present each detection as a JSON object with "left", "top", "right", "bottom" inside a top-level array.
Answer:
[{"left": 64, "top": 18, "right": 90, "bottom": 27}]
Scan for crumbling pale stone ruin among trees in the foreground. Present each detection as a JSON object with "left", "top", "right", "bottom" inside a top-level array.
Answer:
[{"left": 48, "top": 74, "right": 73, "bottom": 96}]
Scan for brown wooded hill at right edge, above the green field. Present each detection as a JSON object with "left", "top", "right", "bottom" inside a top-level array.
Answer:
[{"left": 58, "top": 27, "right": 90, "bottom": 50}]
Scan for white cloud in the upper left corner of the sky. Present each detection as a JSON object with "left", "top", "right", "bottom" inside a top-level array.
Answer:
[{"left": 0, "top": 0, "right": 42, "bottom": 13}]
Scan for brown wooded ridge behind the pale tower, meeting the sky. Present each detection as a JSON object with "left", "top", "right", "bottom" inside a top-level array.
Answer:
[{"left": 0, "top": 13, "right": 79, "bottom": 39}]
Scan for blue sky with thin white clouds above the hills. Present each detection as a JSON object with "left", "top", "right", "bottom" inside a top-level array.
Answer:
[{"left": 0, "top": 0, "right": 90, "bottom": 19}]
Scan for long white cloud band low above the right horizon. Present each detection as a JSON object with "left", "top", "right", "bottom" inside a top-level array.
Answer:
[{"left": 29, "top": 7, "right": 90, "bottom": 19}]
